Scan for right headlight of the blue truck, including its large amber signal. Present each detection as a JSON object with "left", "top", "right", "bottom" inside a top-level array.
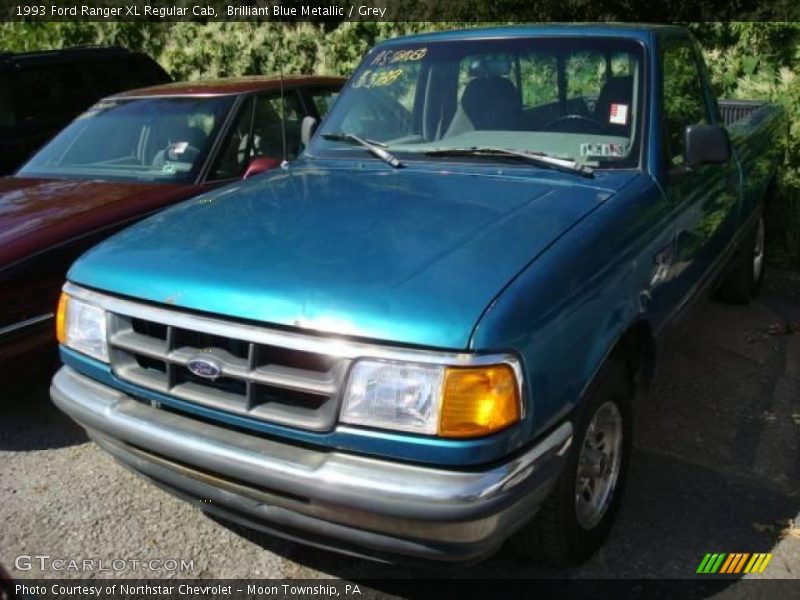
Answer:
[{"left": 340, "top": 360, "right": 522, "bottom": 438}]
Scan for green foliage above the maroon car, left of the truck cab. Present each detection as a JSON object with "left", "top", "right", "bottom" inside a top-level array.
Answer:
[{"left": 0, "top": 22, "right": 460, "bottom": 80}]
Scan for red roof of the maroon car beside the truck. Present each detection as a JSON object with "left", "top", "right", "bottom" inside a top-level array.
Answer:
[{"left": 111, "top": 75, "right": 345, "bottom": 98}]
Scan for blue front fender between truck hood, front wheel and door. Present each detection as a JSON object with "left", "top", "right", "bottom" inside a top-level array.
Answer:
[{"left": 471, "top": 171, "right": 669, "bottom": 439}]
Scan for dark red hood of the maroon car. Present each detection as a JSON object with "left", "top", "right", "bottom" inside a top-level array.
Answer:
[{"left": 0, "top": 177, "right": 201, "bottom": 268}]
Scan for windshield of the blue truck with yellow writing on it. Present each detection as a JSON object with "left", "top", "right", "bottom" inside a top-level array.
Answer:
[{"left": 309, "top": 37, "right": 644, "bottom": 168}]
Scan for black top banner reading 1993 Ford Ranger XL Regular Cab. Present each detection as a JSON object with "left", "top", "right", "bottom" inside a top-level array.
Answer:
[{"left": 0, "top": 0, "right": 800, "bottom": 23}]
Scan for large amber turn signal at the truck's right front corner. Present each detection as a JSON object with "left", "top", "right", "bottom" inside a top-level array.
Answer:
[{"left": 438, "top": 365, "right": 522, "bottom": 437}]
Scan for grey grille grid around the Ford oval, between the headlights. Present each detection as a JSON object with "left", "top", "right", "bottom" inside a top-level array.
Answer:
[{"left": 108, "top": 310, "right": 350, "bottom": 431}]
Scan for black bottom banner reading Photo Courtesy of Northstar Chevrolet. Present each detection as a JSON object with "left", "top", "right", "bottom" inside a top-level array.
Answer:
[{"left": 0, "top": 575, "right": 798, "bottom": 600}]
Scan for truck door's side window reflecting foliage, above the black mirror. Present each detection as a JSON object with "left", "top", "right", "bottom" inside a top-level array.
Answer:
[{"left": 661, "top": 40, "right": 708, "bottom": 167}]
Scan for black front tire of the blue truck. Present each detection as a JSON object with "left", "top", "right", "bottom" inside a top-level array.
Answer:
[{"left": 511, "top": 359, "right": 632, "bottom": 567}]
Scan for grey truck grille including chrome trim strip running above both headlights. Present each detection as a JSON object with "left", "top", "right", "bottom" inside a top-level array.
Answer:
[{"left": 64, "top": 283, "right": 525, "bottom": 431}]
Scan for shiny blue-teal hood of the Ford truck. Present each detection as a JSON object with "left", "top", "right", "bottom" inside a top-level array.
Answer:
[{"left": 69, "top": 163, "right": 633, "bottom": 349}]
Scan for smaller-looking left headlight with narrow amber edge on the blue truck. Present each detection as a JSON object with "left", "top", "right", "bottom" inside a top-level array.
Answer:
[{"left": 56, "top": 293, "right": 108, "bottom": 362}]
